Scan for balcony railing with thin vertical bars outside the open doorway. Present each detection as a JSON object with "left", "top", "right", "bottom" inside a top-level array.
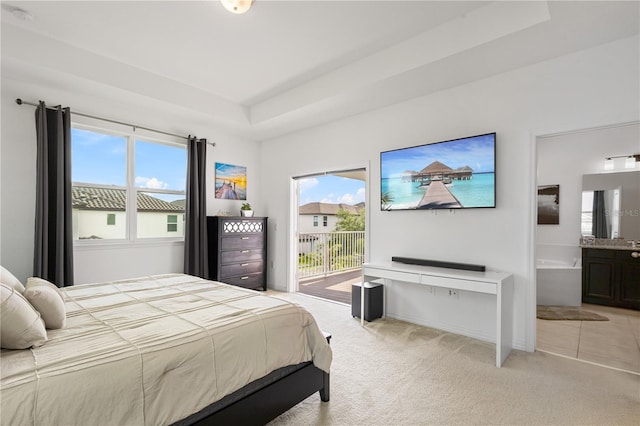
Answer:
[{"left": 298, "top": 231, "right": 365, "bottom": 278}]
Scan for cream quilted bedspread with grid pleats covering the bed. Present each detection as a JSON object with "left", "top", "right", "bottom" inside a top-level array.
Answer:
[{"left": 0, "top": 274, "right": 332, "bottom": 425}]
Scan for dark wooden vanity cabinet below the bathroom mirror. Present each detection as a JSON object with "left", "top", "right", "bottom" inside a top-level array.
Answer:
[{"left": 582, "top": 248, "right": 640, "bottom": 310}]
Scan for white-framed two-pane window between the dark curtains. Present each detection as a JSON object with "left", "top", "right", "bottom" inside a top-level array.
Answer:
[{"left": 71, "top": 125, "right": 187, "bottom": 240}]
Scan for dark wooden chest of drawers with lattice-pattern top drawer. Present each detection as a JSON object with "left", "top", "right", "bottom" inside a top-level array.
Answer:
[{"left": 207, "top": 216, "right": 267, "bottom": 291}]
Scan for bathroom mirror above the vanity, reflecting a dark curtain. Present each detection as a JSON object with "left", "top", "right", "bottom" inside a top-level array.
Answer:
[{"left": 580, "top": 171, "right": 640, "bottom": 240}]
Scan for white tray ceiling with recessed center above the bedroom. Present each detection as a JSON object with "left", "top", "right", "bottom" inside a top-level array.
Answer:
[{"left": 2, "top": 0, "right": 640, "bottom": 140}]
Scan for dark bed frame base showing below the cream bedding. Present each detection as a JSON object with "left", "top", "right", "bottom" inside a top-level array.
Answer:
[{"left": 176, "top": 333, "right": 331, "bottom": 426}]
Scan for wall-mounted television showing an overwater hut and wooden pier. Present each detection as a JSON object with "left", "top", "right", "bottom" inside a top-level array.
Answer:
[{"left": 380, "top": 132, "right": 496, "bottom": 210}]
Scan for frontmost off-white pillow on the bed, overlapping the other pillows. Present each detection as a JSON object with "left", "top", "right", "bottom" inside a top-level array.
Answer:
[{"left": 0, "top": 284, "right": 47, "bottom": 349}]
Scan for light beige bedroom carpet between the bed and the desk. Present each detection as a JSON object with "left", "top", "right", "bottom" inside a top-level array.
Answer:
[{"left": 269, "top": 291, "right": 640, "bottom": 426}]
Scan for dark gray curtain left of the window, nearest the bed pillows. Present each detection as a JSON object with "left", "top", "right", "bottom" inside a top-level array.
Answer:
[{"left": 33, "top": 102, "right": 73, "bottom": 287}]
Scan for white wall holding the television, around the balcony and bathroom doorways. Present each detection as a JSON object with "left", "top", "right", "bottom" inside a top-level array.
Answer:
[{"left": 262, "top": 37, "right": 640, "bottom": 350}]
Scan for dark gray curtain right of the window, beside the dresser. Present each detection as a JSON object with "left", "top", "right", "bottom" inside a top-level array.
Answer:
[{"left": 184, "top": 136, "right": 209, "bottom": 278}]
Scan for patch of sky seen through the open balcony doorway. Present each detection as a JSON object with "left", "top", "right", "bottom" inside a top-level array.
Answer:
[{"left": 298, "top": 175, "right": 365, "bottom": 205}]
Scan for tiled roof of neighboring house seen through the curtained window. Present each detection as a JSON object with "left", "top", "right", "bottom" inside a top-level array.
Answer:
[{"left": 71, "top": 186, "right": 184, "bottom": 213}]
